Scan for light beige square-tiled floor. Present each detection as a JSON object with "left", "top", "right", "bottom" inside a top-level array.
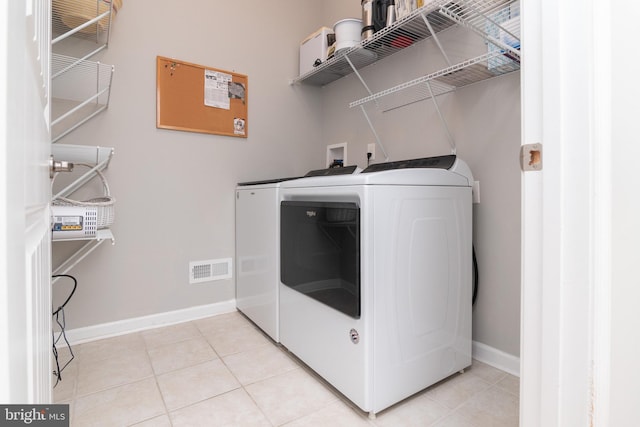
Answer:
[{"left": 54, "top": 312, "right": 519, "bottom": 427}]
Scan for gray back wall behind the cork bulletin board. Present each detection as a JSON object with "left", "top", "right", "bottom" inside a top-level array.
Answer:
[{"left": 54, "top": 0, "right": 324, "bottom": 329}]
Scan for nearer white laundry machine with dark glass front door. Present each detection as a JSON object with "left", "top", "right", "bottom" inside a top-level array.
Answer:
[{"left": 280, "top": 156, "right": 473, "bottom": 415}]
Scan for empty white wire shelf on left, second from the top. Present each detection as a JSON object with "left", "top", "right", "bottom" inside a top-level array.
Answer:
[{"left": 51, "top": 54, "right": 114, "bottom": 142}]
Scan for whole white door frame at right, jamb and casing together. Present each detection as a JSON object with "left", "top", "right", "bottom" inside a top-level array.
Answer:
[{"left": 520, "top": 0, "right": 611, "bottom": 427}]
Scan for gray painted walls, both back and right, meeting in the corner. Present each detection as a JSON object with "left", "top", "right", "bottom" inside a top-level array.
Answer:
[{"left": 57, "top": 0, "right": 520, "bottom": 356}]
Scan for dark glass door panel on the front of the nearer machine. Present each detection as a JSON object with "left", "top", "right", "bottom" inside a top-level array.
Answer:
[{"left": 280, "top": 201, "right": 360, "bottom": 319}]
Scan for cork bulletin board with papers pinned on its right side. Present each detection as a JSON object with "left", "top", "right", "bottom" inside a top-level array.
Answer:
[{"left": 156, "top": 56, "right": 249, "bottom": 138}]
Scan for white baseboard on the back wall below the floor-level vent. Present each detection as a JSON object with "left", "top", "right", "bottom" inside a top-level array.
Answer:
[{"left": 65, "top": 299, "right": 236, "bottom": 345}]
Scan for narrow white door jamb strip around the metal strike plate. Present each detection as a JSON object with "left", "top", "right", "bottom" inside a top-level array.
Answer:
[{"left": 520, "top": 1, "right": 544, "bottom": 427}]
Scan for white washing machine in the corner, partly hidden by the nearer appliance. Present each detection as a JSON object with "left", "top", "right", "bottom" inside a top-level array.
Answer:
[{"left": 235, "top": 166, "right": 360, "bottom": 342}]
